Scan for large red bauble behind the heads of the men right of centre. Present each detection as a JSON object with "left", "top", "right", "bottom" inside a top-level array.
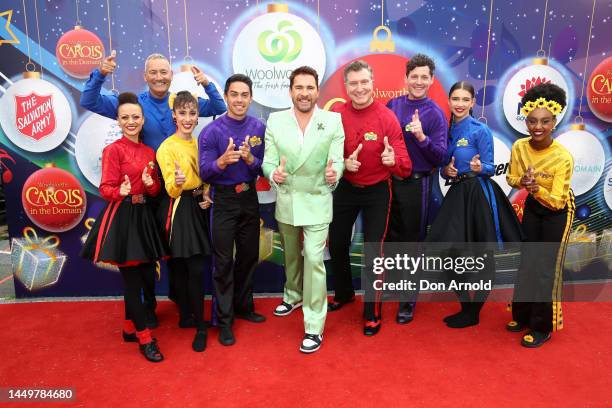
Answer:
[{"left": 319, "top": 54, "right": 450, "bottom": 119}]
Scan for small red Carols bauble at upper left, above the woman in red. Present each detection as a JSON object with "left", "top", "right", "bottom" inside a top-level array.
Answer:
[{"left": 55, "top": 26, "right": 104, "bottom": 78}]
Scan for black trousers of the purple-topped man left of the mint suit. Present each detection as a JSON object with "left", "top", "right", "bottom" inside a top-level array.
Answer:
[{"left": 210, "top": 183, "right": 259, "bottom": 327}]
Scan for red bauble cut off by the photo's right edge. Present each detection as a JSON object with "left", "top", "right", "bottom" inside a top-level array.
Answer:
[{"left": 587, "top": 57, "right": 612, "bottom": 122}]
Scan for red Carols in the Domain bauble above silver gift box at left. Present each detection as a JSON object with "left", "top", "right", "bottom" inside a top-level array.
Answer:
[{"left": 21, "top": 165, "right": 87, "bottom": 232}]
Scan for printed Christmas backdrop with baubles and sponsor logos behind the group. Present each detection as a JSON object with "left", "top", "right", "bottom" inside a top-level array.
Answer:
[{"left": 0, "top": 0, "right": 612, "bottom": 297}]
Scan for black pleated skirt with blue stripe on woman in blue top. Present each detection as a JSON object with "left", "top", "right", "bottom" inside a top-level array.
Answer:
[{"left": 427, "top": 177, "right": 522, "bottom": 242}]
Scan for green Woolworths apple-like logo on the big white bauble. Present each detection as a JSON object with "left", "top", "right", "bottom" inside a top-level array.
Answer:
[{"left": 257, "top": 20, "right": 302, "bottom": 63}]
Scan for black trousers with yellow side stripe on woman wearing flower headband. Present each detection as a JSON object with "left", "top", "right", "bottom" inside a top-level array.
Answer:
[{"left": 512, "top": 190, "right": 575, "bottom": 333}]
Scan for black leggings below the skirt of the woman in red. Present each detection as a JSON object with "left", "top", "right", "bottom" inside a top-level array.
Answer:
[{"left": 119, "top": 263, "right": 155, "bottom": 331}]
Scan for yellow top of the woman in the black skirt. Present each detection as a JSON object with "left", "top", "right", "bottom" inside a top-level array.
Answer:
[{"left": 157, "top": 133, "right": 202, "bottom": 198}]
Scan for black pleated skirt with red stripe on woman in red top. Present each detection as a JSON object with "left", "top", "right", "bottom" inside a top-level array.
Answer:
[{"left": 81, "top": 200, "right": 168, "bottom": 266}]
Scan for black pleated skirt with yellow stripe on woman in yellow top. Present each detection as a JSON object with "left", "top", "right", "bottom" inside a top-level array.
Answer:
[{"left": 157, "top": 191, "right": 212, "bottom": 258}]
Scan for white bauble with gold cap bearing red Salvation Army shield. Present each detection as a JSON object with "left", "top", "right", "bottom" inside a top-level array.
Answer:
[{"left": 0, "top": 72, "right": 72, "bottom": 153}]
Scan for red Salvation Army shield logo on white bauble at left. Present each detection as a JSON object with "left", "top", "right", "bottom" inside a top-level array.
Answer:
[{"left": 15, "top": 92, "right": 55, "bottom": 141}]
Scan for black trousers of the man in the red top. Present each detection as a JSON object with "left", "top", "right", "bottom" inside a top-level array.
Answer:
[{"left": 329, "top": 179, "right": 391, "bottom": 320}]
